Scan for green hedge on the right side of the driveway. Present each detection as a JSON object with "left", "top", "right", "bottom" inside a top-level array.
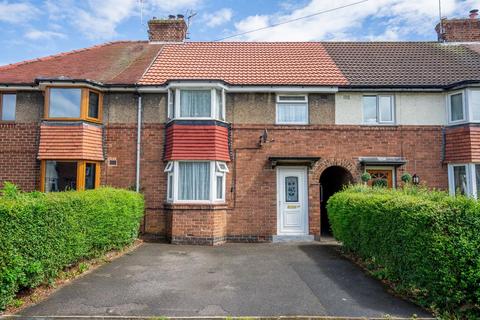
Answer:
[{"left": 327, "top": 186, "right": 480, "bottom": 319}]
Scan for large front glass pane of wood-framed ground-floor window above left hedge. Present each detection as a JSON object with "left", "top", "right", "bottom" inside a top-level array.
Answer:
[{"left": 45, "top": 161, "right": 77, "bottom": 192}]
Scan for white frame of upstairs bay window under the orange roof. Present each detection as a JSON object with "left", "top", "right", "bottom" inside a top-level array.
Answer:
[{"left": 167, "top": 86, "right": 226, "bottom": 122}]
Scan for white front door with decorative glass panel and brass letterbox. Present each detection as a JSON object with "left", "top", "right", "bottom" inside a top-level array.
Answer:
[{"left": 277, "top": 166, "right": 308, "bottom": 236}]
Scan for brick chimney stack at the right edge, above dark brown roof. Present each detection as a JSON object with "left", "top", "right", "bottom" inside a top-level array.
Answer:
[{"left": 435, "top": 9, "right": 480, "bottom": 42}]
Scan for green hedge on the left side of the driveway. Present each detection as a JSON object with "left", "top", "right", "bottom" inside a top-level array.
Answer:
[{"left": 0, "top": 185, "right": 144, "bottom": 310}]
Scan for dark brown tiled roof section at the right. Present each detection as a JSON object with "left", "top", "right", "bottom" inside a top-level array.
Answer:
[{"left": 323, "top": 42, "right": 480, "bottom": 87}]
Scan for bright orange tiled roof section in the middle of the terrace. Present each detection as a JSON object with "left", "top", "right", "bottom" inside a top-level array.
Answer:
[{"left": 140, "top": 42, "right": 347, "bottom": 86}]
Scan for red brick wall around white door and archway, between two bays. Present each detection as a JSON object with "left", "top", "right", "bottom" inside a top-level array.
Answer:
[{"left": 227, "top": 125, "right": 448, "bottom": 238}]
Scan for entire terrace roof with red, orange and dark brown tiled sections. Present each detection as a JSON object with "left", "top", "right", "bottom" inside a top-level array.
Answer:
[{"left": 0, "top": 41, "right": 480, "bottom": 88}]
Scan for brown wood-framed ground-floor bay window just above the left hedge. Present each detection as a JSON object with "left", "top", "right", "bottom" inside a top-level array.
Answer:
[{"left": 40, "top": 160, "right": 100, "bottom": 192}]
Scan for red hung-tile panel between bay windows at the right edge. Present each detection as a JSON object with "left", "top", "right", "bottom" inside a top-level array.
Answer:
[{"left": 445, "top": 124, "right": 480, "bottom": 163}]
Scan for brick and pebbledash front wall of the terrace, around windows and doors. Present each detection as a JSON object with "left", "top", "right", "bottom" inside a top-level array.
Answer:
[{"left": 0, "top": 92, "right": 447, "bottom": 244}]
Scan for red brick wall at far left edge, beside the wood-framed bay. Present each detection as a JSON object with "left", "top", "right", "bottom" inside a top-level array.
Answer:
[{"left": 0, "top": 123, "right": 40, "bottom": 191}]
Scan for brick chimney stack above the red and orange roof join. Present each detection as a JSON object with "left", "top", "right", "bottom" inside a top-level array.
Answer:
[{"left": 148, "top": 14, "right": 187, "bottom": 42}]
